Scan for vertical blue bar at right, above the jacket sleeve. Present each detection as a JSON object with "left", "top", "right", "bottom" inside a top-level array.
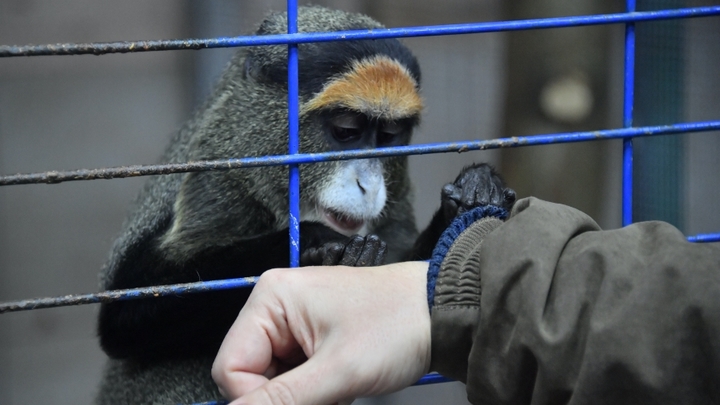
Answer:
[{"left": 622, "top": 0, "right": 635, "bottom": 226}]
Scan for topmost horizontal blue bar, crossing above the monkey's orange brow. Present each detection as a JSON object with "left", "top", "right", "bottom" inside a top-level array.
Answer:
[{"left": 0, "top": 6, "right": 720, "bottom": 57}]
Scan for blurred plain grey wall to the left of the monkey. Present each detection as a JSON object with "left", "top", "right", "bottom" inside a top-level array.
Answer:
[{"left": 0, "top": 0, "right": 191, "bottom": 405}]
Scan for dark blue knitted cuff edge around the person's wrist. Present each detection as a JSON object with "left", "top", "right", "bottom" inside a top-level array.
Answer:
[{"left": 427, "top": 205, "right": 508, "bottom": 313}]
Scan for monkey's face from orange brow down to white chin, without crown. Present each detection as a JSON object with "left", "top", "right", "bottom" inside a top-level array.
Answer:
[{"left": 296, "top": 55, "right": 422, "bottom": 235}]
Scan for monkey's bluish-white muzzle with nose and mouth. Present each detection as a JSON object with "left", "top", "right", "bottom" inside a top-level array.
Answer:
[{"left": 301, "top": 159, "right": 387, "bottom": 236}]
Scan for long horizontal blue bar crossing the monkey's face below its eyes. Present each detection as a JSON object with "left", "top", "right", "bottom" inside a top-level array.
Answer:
[{"left": 0, "top": 120, "right": 720, "bottom": 186}]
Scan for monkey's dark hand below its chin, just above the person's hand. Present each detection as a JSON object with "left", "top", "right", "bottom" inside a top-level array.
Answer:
[{"left": 300, "top": 235, "right": 387, "bottom": 267}]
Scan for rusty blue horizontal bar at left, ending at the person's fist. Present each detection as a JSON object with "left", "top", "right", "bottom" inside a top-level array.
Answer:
[{"left": 0, "top": 277, "right": 259, "bottom": 314}]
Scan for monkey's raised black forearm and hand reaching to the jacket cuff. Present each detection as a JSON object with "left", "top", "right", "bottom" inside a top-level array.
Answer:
[{"left": 405, "top": 163, "right": 515, "bottom": 260}]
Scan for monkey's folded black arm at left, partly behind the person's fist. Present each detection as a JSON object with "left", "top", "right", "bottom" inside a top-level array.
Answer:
[{"left": 98, "top": 223, "right": 347, "bottom": 359}]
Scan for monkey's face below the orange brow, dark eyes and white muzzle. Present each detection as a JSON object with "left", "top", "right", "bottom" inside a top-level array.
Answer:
[{"left": 302, "top": 108, "right": 417, "bottom": 236}]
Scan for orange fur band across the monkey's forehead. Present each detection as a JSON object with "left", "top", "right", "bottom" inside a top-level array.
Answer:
[{"left": 303, "top": 56, "right": 423, "bottom": 120}]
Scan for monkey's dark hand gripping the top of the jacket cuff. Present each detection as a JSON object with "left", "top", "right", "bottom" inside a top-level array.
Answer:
[{"left": 441, "top": 163, "right": 516, "bottom": 225}]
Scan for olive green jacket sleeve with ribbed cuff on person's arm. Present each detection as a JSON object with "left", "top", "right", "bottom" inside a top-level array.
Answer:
[{"left": 431, "top": 198, "right": 720, "bottom": 405}]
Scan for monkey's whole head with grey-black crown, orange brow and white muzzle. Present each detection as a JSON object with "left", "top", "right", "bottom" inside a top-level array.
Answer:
[{"left": 241, "top": 27, "right": 423, "bottom": 235}]
